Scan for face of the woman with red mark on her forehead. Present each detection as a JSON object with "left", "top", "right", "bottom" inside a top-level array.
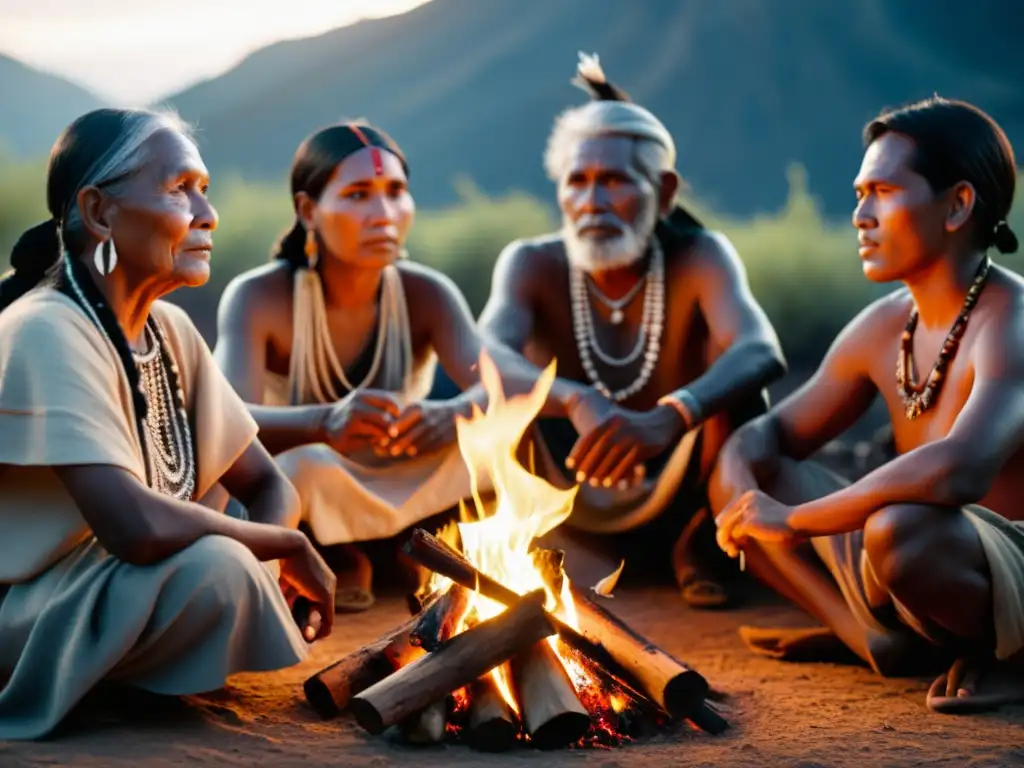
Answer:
[{"left": 311, "top": 147, "right": 416, "bottom": 268}]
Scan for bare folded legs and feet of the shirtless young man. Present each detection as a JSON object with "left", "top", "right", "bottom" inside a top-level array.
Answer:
[{"left": 711, "top": 461, "right": 1024, "bottom": 713}]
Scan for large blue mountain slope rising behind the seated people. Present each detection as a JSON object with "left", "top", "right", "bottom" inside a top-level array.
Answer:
[{"left": 0, "top": 0, "right": 1024, "bottom": 215}]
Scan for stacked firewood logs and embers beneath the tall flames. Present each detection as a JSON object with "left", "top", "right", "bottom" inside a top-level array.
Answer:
[{"left": 304, "top": 529, "right": 728, "bottom": 752}]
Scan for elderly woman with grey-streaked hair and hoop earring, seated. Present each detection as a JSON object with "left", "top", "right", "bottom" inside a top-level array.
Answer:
[{"left": 0, "top": 110, "right": 334, "bottom": 740}]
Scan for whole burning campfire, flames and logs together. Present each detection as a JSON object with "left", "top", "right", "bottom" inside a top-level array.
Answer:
[{"left": 304, "top": 355, "right": 727, "bottom": 751}]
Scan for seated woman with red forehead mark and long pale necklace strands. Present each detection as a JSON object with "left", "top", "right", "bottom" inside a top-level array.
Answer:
[{"left": 216, "top": 123, "right": 532, "bottom": 610}]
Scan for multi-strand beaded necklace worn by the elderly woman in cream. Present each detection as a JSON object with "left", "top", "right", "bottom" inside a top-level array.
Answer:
[{"left": 65, "top": 254, "right": 196, "bottom": 501}]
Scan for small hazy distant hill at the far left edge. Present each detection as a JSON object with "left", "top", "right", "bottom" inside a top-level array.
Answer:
[{"left": 0, "top": 54, "right": 103, "bottom": 157}]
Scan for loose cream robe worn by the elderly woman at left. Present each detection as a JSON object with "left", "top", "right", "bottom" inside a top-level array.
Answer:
[{"left": 0, "top": 288, "right": 306, "bottom": 740}]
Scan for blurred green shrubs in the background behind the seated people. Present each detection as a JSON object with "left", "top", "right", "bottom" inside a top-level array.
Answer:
[{"left": 0, "top": 155, "right": 1024, "bottom": 367}]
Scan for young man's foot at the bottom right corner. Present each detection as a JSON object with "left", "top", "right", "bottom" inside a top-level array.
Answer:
[{"left": 925, "top": 658, "right": 1024, "bottom": 715}]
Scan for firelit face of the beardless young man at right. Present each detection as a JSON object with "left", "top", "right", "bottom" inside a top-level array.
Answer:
[{"left": 853, "top": 133, "right": 950, "bottom": 283}]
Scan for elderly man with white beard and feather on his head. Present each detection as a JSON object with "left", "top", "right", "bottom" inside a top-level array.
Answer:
[{"left": 480, "top": 55, "right": 785, "bottom": 608}]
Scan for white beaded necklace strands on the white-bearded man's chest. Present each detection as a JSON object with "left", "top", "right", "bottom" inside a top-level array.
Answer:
[{"left": 569, "top": 239, "right": 665, "bottom": 402}]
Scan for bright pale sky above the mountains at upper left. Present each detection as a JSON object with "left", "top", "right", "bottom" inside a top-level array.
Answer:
[{"left": 0, "top": 0, "right": 427, "bottom": 105}]
